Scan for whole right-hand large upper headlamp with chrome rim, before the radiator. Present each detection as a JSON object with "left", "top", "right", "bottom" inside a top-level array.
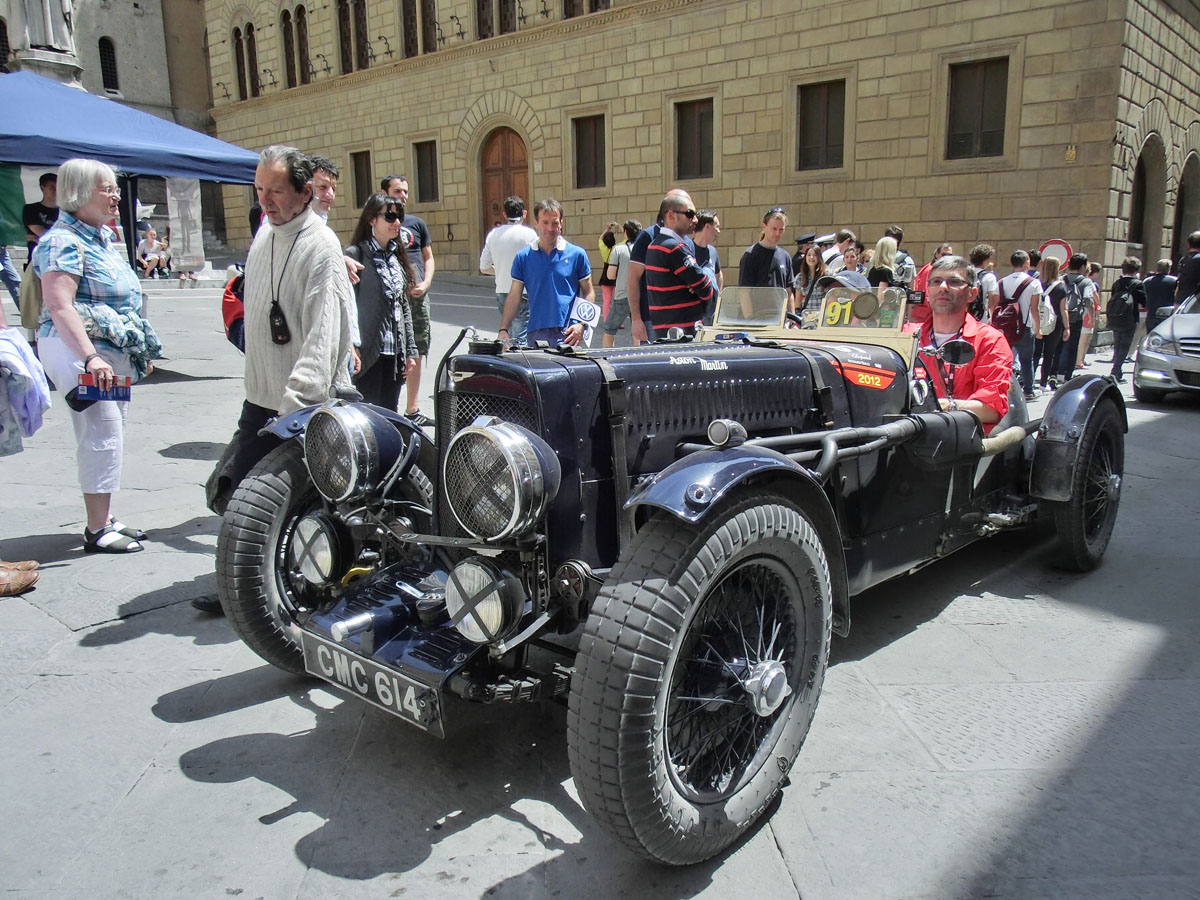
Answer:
[{"left": 442, "top": 415, "right": 562, "bottom": 541}]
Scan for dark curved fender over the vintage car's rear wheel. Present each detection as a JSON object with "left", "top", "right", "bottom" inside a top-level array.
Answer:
[{"left": 1030, "top": 376, "right": 1129, "bottom": 500}]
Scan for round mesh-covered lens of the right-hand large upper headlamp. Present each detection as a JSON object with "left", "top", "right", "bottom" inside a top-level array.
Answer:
[{"left": 443, "top": 433, "right": 516, "bottom": 540}]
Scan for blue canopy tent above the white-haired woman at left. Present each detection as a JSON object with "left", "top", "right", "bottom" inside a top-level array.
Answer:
[{"left": 0, "top": 72, "right": 258, "bottom": 264}]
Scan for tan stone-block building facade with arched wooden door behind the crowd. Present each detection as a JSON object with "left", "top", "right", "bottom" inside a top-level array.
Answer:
[{"left": 205, "top": 0, "right": 1200, "bottom": 282}]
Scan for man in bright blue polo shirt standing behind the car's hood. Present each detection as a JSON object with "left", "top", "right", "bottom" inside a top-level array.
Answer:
[{"left": 499, "top": 199, "right": 592, "bottom": 347}]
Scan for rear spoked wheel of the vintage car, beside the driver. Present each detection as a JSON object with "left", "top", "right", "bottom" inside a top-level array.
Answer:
[{"left": 1054, "top": 401, "right": 1124, "bottom": 572}]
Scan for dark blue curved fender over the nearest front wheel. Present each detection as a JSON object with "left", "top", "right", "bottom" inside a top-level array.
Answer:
[{"left": 625, "top": 446, "right": 850, "bottom": 637}]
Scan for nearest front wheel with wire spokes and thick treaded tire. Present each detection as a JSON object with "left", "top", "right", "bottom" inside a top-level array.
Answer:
[{"left": 568, "top": 494, "right": 832, "bottom": 865}]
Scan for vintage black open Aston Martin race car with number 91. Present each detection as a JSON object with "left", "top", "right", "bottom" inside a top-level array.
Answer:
[{"left": 217, "top": 288, "right": 1127, "bottom": 864}]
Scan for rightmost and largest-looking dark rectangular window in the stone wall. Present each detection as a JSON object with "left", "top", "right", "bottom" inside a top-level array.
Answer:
[{"left": 946, "top": 58, "right": 1008, "bottom": 160}]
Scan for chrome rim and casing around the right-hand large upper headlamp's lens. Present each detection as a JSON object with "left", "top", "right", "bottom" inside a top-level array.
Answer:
[{"left": 442, "top": 416, "right": 557, "bottom": 541}]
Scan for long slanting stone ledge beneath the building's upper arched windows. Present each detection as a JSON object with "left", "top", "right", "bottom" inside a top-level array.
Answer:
[{"left": 209, "top": 0, "right": 704, "bottom": 126}]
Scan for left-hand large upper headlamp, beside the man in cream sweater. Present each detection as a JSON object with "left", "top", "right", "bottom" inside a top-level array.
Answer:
[{"left": 304, "top": 401, "right": 404, "bottom": 503}]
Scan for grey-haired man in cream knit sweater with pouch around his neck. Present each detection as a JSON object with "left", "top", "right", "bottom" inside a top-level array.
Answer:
[{"left": 230, "top": 145, "right": 354, "bottom": 488}]
